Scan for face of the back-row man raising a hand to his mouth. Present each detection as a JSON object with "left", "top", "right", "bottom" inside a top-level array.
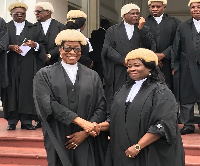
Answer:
[{"left": 123, "top": 9, "right": 139, "bottom": 25}]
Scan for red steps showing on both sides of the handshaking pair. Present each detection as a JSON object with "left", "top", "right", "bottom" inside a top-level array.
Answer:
[{"left": 0, "top": 118, "right": 200, "bottom": 166}]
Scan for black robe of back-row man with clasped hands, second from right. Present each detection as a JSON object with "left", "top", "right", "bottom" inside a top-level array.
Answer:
[{"left": 145, "top": 14, "right": 180, "bottom": 90}]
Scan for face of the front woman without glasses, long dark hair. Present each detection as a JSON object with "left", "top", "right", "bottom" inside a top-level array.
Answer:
[{"left": 127, "top": 59, "right": 151, "bottom": 81}]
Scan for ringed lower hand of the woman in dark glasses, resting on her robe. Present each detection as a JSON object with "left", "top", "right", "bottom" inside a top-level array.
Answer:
[{"left": 65, "top": 131, "right": 88, "bottom": 149}]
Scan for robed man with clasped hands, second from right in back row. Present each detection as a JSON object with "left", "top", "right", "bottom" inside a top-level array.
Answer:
[{"left": 145, "top": 0, "right": 180, "bottom": 90}]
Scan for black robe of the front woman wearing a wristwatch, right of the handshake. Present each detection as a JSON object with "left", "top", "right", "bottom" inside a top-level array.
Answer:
[{"left": 105, "top": 82, "right": 185, "bottom": 166}]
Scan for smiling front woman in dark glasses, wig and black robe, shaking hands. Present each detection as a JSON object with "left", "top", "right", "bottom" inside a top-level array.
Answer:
[{"left": 34, "top": 29, "right": 108, "bottom": 166}]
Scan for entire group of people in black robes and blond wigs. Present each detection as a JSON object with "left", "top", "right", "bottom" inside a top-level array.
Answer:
[{"left": 0, "top": 0, "right": 200, "bottom": 166}]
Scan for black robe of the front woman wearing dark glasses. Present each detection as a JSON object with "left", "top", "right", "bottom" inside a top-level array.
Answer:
[{"left": 34, "top": 62, "right": 107, "bottom": 166}]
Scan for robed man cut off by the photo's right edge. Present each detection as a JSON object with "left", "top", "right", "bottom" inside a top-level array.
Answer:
[{"left": 172, "top": 0, "right": 200, "bottom": 134}]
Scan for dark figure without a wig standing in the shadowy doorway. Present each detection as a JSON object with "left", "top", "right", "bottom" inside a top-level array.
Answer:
[{"left": 90, "top": 19, "right": 110, "bottom": 82}]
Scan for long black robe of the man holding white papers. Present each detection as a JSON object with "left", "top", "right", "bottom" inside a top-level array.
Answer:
[{"left": 3, "top": 21, "right": 46, "bottom": 119}]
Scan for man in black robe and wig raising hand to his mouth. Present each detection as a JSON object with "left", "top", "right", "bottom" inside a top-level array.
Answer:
[{"left": 102, "top": 4, "right": 156, "bottom": 113}]
